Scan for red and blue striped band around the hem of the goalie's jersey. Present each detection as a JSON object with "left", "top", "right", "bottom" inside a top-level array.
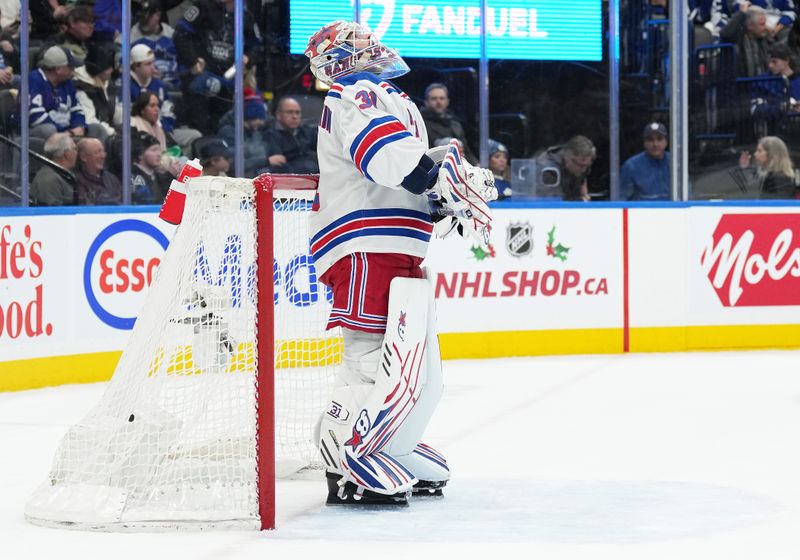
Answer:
[{"left": 311, "top": 208, "right": 433, "bottom": 260}]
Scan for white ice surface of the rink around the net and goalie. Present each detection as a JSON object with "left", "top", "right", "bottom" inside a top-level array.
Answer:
[{"left": 0, "top": 351, "right": 800, "bottom": 560}]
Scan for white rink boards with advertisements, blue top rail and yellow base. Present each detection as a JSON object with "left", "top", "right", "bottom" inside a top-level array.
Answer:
[{"left": 0, "top": 201, "right": 800, "bottom": 391}]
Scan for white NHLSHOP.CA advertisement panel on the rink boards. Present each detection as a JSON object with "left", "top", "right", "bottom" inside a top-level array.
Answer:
[{"left": 426, "top": 209, "right": 623, "bottom": 332}]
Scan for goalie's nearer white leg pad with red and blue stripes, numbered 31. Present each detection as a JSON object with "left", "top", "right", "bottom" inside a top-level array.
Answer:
[{"left": 320, "top": 278, "right": 438, "bottom": 494}]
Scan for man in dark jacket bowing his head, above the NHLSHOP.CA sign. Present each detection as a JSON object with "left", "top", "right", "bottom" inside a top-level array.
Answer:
[{"left": 535, "top": 135, "right": 597, "bottom": 202}]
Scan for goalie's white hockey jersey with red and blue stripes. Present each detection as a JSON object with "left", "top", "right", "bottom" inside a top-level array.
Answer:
[{"left": 310, "top": 72, "right": 433, "bottom": 275}]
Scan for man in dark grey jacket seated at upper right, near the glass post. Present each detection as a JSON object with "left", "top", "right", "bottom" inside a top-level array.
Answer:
[{"left": 719, "top": 6, "right": 773, "bottom": 78}]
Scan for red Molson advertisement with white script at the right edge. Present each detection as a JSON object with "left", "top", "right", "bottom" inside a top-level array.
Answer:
[{"left": 700, "top": 213, "right": 800, "bottom": 307}]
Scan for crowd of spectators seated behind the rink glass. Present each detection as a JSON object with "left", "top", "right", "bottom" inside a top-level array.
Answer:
[{"left": 0, "top": 0, "right": 800, "bottom": 205}]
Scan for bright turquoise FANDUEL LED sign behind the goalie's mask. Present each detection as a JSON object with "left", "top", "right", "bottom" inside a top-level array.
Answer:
[{"left": 290, "top": 0, "right": 603, "bottom": 61}]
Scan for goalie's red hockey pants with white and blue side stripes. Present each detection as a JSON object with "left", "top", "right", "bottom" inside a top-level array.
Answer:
[{"left": 320, "top": 253, "right": 423, "bottom": 333}]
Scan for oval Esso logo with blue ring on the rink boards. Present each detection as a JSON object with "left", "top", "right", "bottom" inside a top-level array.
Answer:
[{"left": 83, "top": 219, "right": 169, "bottom": 330}]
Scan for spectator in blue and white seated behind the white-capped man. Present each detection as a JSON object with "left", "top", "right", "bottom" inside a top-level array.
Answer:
[{"left": 131, "top": 0, "right": 181, "bottom": 90}]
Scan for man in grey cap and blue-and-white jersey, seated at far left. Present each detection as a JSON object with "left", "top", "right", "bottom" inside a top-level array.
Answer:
[{"left": 28, "top": 46, "right": 86, "bottom": 139}]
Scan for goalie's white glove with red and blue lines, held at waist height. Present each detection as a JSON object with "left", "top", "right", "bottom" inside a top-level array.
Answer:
[{"left": 425, "top": 140, "right": 497, "bottom": 250}]
